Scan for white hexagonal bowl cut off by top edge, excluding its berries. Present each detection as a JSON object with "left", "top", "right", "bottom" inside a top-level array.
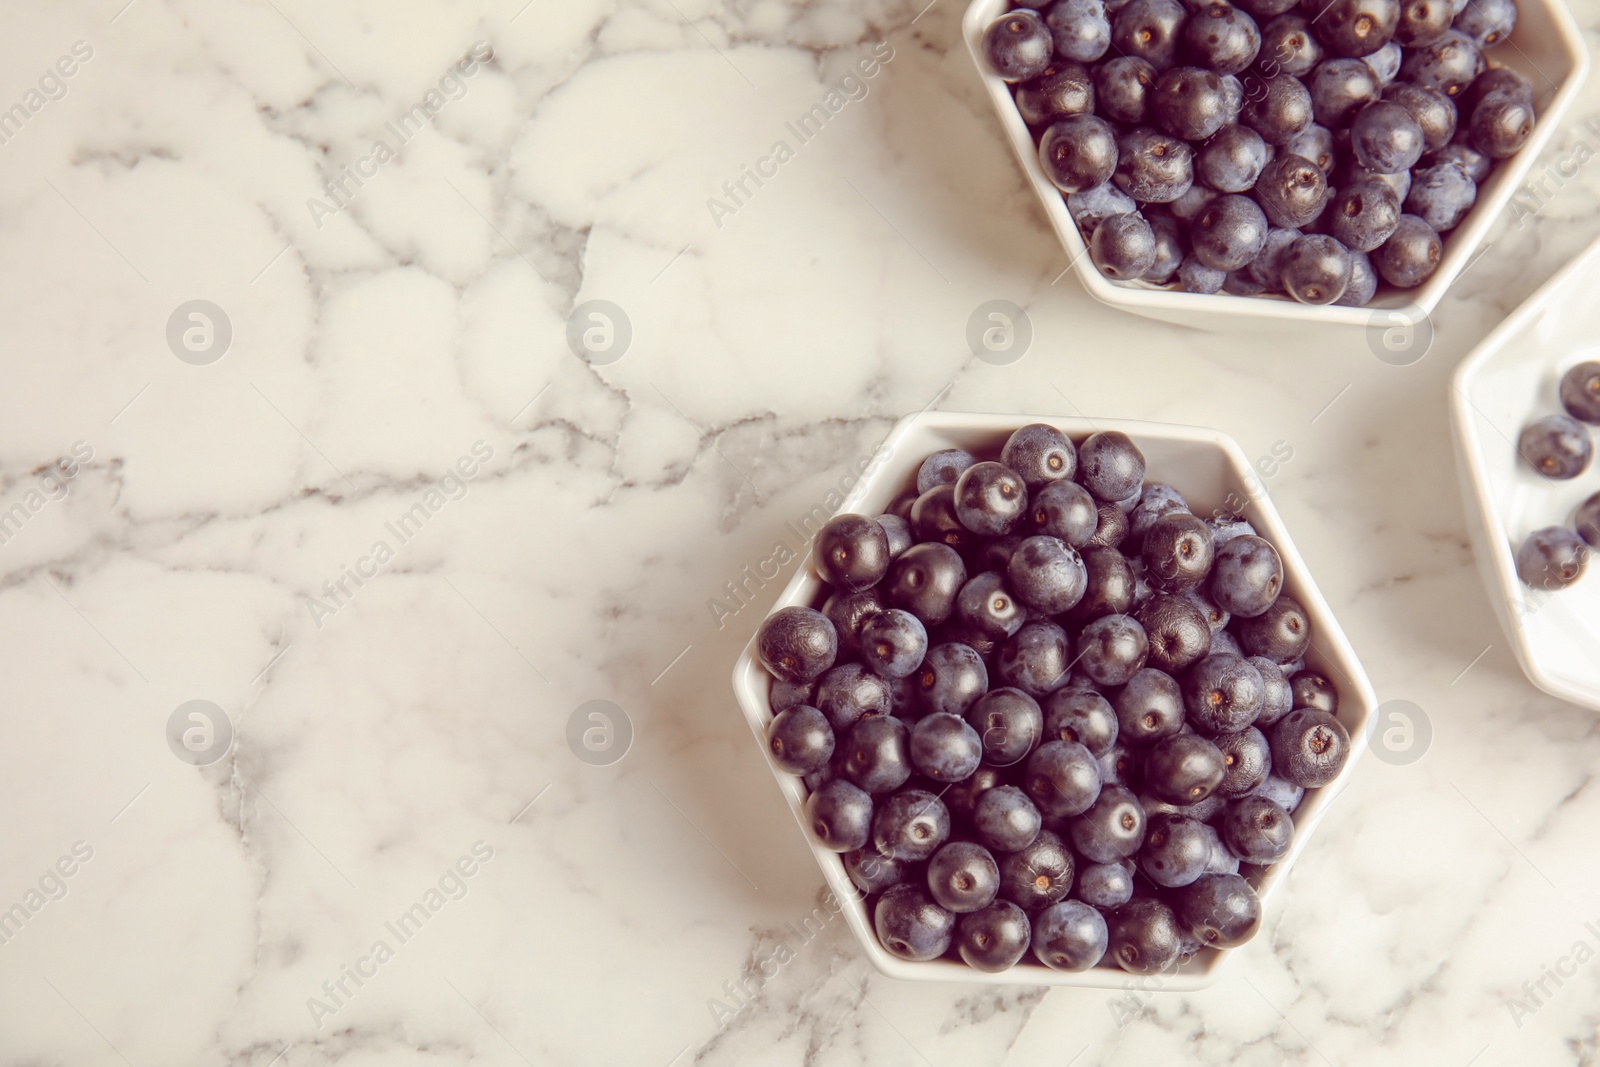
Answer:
[{"left": 962, "top": 0, "right": 1589, "bottom": 331}]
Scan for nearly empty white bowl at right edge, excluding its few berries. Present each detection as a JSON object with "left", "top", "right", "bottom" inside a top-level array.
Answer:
[{"left": 1451, "top": 242, "right": 1600, "bottom": 710}]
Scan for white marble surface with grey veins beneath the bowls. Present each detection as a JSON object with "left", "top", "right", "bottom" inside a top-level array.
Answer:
[{"left": 0, "top": 0, "right": 1600, "bottom": 1067}]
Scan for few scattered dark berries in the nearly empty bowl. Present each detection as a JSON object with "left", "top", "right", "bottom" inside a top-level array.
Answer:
[{"left": 1517, "top": 360, "right": 1600, "bottom": 592}]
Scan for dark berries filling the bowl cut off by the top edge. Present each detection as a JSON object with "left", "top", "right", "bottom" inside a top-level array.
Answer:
[{"left": 984, "top": 0, "right": 1534, "bottom": 306}]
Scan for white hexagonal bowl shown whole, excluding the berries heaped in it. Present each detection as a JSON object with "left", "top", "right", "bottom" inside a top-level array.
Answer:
[{"left": 733, "top": 411, "right": 1376, "bottom": 990}]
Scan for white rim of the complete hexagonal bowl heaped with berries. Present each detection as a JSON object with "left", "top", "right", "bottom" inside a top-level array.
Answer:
[{"left": 733, "top": 411, "right": 1378, "bottom": 992}]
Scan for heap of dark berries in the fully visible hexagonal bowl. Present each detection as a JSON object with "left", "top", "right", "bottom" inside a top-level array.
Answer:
[{"left": 757, "top": 424, "right": 1350, "bottom": 974}]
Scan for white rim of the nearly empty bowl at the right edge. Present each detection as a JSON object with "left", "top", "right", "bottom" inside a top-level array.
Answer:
[{"left": 1450, "top": 227, "right": 1600, "bottom": 710}]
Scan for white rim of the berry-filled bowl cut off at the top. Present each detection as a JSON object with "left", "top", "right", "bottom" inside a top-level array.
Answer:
[{"left": 962, "top": 0, "right": 1590, "bottom": 326}]
